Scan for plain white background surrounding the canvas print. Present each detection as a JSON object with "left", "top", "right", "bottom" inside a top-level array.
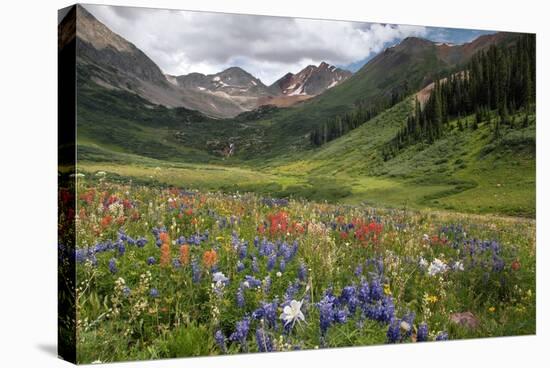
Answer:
[{"left": 0, "top": 0, "right": 550, "bottom": 368}]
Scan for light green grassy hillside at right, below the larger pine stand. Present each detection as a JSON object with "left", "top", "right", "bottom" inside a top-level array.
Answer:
[{"left": 270, "top": 101, "right": 535, "bottom": 216}]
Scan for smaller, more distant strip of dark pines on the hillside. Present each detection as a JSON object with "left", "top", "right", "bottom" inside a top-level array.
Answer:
[{"left": 309, "top": 83, "right": 409, "bottom": 146}]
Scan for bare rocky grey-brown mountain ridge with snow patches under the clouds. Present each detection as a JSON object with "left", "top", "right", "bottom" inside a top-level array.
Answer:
[{"left": 77, "top": 5, "right": 348, "bottom": 118}]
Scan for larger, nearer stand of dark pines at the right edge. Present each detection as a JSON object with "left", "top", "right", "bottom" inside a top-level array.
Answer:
[{"left": 382, "top": 35, "right": 536, "bottom": 160}]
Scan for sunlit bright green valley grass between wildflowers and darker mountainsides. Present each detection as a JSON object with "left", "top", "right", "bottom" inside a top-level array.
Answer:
[{"left": 79, "top": 91, "right": 535, "bottom": 216}]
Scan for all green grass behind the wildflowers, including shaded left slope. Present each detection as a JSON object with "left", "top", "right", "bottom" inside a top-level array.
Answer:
[{"left": 78, "top": 83, "right": 535, "bottom": 217}]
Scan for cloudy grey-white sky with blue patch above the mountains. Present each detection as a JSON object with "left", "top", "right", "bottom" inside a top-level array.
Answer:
[{"left": 85, "top": 5, "right": 498, "bottom": 85}]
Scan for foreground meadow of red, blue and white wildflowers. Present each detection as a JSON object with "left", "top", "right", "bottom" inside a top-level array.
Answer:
[{"left": 59, "top": 177, "right": 535, "bottom": 363}]
